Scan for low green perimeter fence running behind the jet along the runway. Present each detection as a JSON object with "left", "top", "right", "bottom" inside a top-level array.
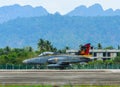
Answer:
[{"left": 0, "top": 64, "right": 120, "bottom": 69}]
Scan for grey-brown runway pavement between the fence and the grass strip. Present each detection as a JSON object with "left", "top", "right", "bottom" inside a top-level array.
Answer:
[{"left": 0, "top": 70, "right": 120, "bottom": 85}]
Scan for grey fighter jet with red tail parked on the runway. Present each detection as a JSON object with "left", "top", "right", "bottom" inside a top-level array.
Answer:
[{"left": 23, "top": 44, "right": 91, "bottom": 68}]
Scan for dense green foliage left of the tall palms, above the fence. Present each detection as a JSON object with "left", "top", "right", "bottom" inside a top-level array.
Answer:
[{"left": 0, "top": 46, "right": 36, "bottom": 64}]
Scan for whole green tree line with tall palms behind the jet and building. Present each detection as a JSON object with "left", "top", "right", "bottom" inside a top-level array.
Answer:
[{"left": 0, "top": 39, "right": 120, "bottom": 64}]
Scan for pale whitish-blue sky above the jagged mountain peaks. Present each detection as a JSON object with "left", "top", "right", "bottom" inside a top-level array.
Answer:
[{"left": 0, "top": 0, "right": 120, "bottom": 14}]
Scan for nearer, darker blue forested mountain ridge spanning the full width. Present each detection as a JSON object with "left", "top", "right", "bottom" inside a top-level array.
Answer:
[{"left": 0, "top": 13, "right": 120, "bottom": 49}]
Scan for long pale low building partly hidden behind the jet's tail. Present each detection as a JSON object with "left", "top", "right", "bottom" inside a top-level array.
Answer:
[{"left": 66, "top": 49, "right": 120, "bottom": 60}]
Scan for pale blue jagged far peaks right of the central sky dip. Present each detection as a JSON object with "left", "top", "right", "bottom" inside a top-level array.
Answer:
[{"left": 66, "top": 4, "right": 120, "bottom": 16}]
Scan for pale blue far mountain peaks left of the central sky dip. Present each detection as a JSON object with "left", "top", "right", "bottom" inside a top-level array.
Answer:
[{"left": 0, "top": 4, "right": 49, "bottom": 23}]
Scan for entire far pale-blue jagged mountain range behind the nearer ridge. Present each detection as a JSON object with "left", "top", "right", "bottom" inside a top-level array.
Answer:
[{"left": 0, "top": 4, "right": 120, "bottom": 23}]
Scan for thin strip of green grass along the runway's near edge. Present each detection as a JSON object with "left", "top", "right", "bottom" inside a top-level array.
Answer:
[{"left": 0, "top": 84, "right": 120, "bottom": 87}]
